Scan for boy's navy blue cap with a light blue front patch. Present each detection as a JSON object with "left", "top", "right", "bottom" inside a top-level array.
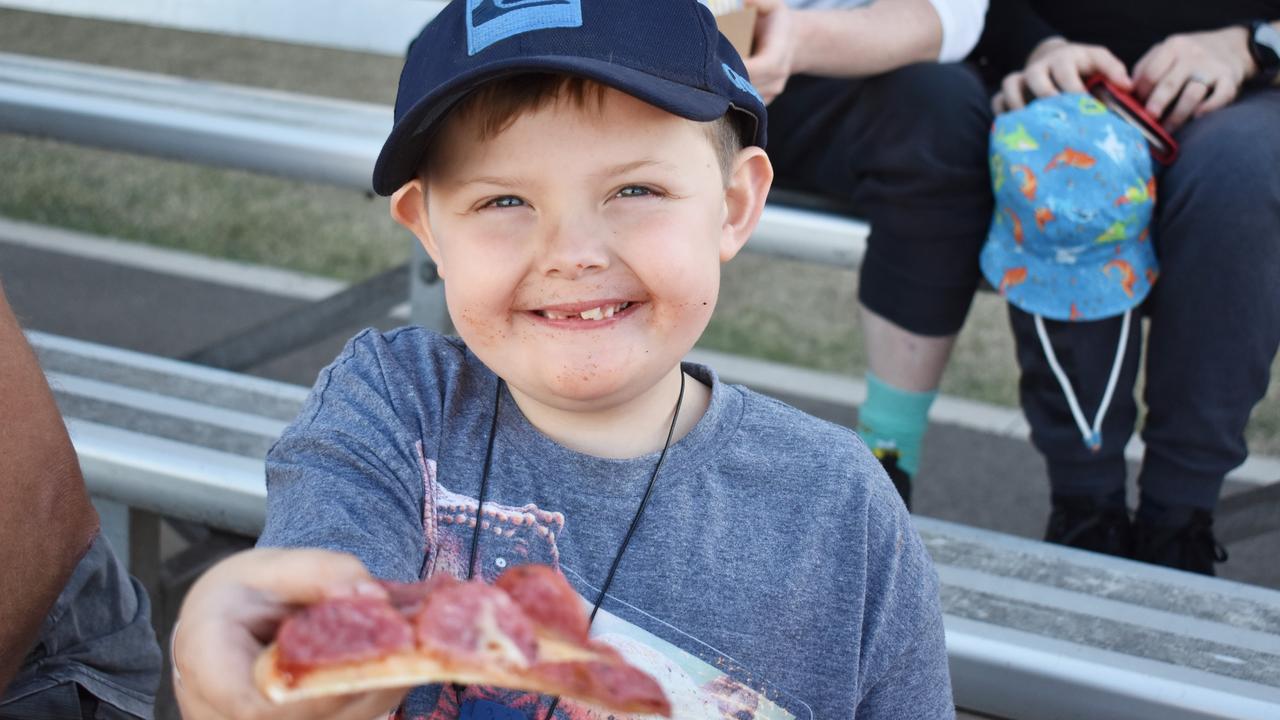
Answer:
[{"left": 374, "top": 0, "right": 765, "bottom": 195}]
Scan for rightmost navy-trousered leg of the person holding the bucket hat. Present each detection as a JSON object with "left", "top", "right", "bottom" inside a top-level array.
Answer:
[{"left": 1139, "top": 90, "right": 1280, "bottom": 524}]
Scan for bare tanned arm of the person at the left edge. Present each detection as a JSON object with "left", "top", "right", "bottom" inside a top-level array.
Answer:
[{"left": 0, "top": 280, "right": 99, "bottom": 694}]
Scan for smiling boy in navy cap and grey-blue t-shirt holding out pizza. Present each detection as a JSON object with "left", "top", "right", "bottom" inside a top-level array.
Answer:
[{"left": 175, "top": 0, "right": 954, "bottom": 719}]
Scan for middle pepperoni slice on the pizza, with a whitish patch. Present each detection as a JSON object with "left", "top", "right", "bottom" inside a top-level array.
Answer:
[{"left": 413, "top": 582, "right": 538, "bottom": 665}]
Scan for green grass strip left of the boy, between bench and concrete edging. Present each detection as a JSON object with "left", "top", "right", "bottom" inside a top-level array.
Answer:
[{"left": 0, "top": 135, "right": 410, "bottom": 281}]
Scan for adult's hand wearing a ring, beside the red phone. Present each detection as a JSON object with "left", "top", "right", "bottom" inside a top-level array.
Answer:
[{"left": 1133, "top": 27, "right": 1253, "bottom": 132}]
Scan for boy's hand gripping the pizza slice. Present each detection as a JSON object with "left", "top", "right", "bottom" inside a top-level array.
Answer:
[{"left": 173, "top": 550, "right": 404, "bottom": 720}]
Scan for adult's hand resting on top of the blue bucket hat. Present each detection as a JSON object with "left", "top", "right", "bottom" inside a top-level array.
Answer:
[{"left": 991, "top": 37, "right": 1133, "bottom": 113}]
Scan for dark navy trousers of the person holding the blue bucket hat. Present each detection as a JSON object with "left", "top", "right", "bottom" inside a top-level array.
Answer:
[{"left": 1010, "top": 90, "right": 1280, "bottom": 510}]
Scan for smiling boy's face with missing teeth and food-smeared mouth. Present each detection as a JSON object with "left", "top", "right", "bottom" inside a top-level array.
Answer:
[{"left": 392, "top": 90, "right": 772, "bottom": 410}]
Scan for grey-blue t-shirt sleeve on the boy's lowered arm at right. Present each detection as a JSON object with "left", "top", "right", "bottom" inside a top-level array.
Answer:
[{"left": 856, "top": 483, "right": 955, "bottom": 720}]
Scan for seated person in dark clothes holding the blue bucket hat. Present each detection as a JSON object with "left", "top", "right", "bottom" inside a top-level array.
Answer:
[{"left": 978, "top": 0, "right": 1280, "bottom": 574}]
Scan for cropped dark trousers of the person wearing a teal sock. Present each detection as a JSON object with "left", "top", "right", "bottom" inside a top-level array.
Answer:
[{"left": 768, "top": 63, "right": 992, "bottom": 336}]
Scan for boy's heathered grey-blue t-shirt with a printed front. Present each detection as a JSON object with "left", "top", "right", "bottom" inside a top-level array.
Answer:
[{"left": 260, "top": 328, "right": 954, "bottom": 720}]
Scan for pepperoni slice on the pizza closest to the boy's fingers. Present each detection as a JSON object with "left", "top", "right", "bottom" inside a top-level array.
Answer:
[{"left": 276, "top": 597, "right": 413, "bottom": 674}]
